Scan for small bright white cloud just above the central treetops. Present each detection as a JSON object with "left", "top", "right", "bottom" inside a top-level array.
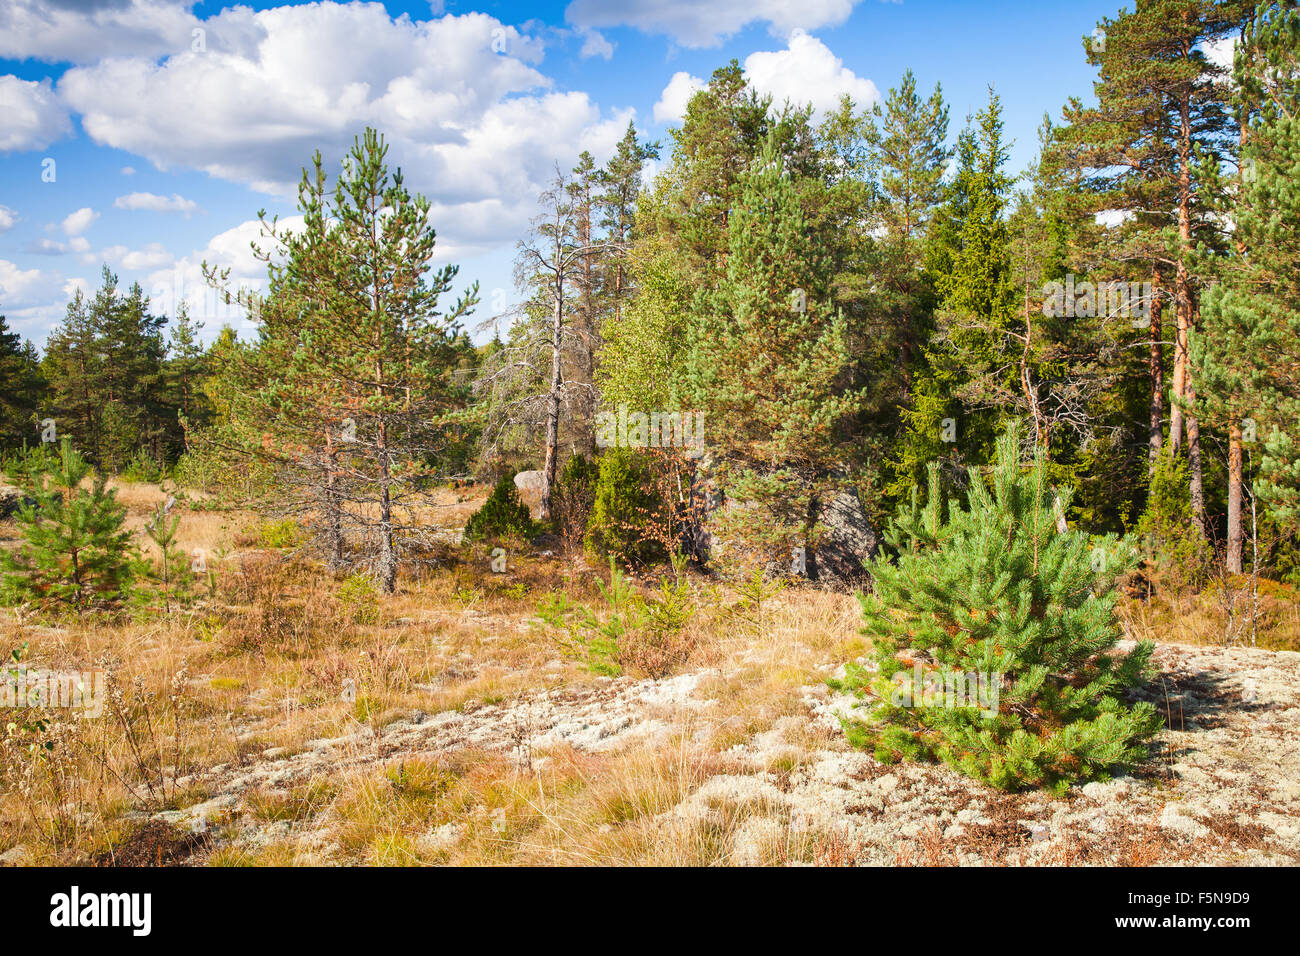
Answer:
[{"left": 745, "top": 30, "right": 880, "bottom": 116}]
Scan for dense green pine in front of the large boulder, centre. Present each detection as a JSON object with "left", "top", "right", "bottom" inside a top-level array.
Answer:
[{"left": 683, "top": 135, "right": 862, "bottom": 567}]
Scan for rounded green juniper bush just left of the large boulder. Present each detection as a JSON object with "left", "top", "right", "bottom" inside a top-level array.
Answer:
[{"left": 586, "top": 449, "right": 667, "bottom": 563}]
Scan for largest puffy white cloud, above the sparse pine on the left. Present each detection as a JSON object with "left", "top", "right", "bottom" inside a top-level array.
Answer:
[{"left": 59, "top": 3, "right": 631, "bottom": 251}]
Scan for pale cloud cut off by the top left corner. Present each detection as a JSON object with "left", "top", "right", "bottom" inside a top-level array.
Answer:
[{"left": 0, "top": 0, "right": 200, "bottom": 64}]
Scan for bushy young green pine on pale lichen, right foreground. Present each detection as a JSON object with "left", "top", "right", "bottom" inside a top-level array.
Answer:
[{"left": 844, "top": 425, "right": 1160, "bottom": 792}]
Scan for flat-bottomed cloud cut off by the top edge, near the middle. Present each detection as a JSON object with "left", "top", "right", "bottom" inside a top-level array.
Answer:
[{"left": 564, "top": 0, "right": 861, "bottom": 48}]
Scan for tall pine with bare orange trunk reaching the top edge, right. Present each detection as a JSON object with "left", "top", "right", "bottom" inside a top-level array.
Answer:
[{"left": 1062, "top": 0, "right": 1253, "bottom": 533}]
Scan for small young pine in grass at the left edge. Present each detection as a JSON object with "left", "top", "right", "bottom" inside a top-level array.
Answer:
[{"left": 0, "top": 438, "right": 131, "bottom": 613}]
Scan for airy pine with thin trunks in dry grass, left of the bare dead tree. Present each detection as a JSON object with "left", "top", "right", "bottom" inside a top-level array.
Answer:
[{"left": 204, "top": 129, "right": 477, "bottom": 592}]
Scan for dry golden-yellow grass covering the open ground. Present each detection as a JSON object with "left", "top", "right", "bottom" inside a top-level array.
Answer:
[{"left": 0, "top": 485, "right": 1300, "bottom": 865}]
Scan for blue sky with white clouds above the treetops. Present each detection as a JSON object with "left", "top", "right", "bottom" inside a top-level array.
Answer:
[{"left": 0, "top": 0, "right": 1118, "bottom": 345}]
